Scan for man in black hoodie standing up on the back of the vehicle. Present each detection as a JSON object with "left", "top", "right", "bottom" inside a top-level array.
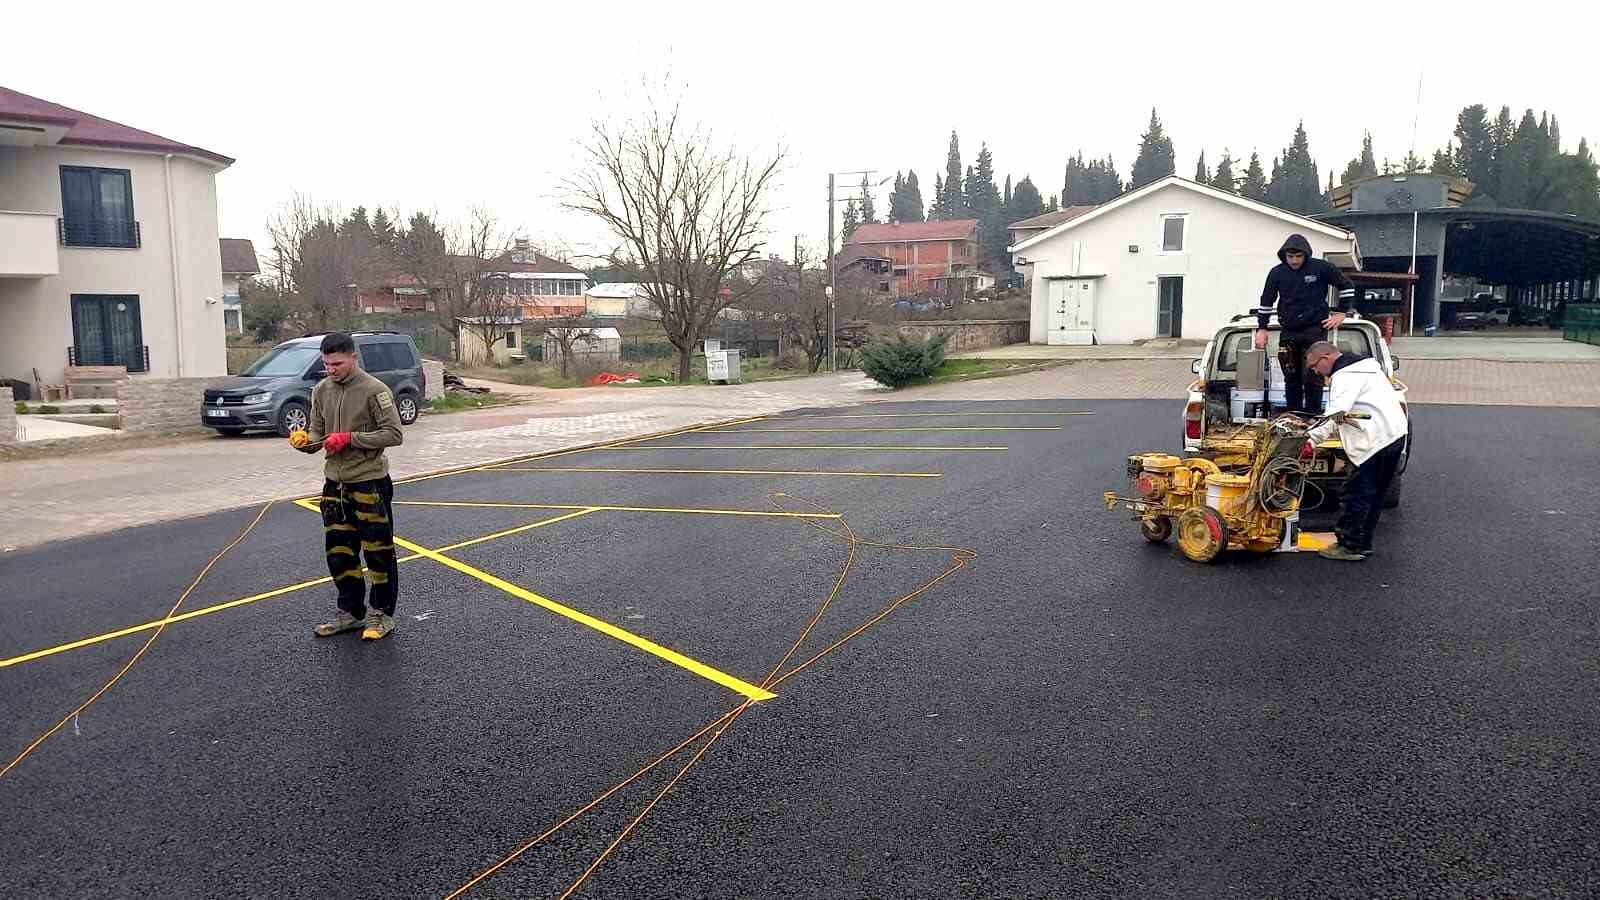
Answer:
[{"left": 1256, "top": 234, "right": 1355, "bottom": 415}]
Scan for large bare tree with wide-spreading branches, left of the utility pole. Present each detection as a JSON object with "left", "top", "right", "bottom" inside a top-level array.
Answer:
[{"left": 565, "top": 96, "right": 784, "bottom": 381}]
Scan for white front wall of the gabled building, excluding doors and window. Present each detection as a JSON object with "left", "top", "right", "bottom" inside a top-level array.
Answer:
[{"left": 1021, "top": 184, "right": 1350, "bottom": 344}]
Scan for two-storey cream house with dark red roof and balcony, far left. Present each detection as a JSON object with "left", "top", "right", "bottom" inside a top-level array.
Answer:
[{"left": 0, "top": 88, "right": 234, "bottom": 384}]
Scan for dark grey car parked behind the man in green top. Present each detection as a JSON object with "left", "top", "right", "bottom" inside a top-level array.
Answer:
[{"left": 200, "top": 331, "right": 427, "bottom": 437}]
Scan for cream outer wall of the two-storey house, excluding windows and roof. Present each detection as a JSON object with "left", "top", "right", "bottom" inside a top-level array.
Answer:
[{"left": 0, "top": 147, "right": 227, "bottom": 383}]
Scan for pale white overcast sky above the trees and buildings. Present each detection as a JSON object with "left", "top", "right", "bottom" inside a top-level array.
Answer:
[{"left": 0, "top": 0, "right": 1600, "bottom": 264}]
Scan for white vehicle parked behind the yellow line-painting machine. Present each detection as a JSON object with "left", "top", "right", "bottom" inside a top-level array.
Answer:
[{"left": 1182, "top": 315, "right": 1414, "bottom": 508}]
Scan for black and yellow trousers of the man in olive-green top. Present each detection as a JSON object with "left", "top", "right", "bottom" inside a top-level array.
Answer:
[{"left": 322, "top": 476, "right": 400, "bottom": 618}]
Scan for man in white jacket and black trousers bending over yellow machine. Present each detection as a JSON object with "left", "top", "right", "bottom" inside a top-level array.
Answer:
[{"left": 1306, "top": 341, "right": 1406, "bottom": 562}]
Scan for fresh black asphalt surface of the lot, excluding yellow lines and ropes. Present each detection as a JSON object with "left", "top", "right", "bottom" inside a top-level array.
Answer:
[{"left": 0, "top": 402, "right": 1600, "bottom": 898}]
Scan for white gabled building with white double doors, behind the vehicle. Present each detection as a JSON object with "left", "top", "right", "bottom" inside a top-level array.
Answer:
[{"left": 1010, "top": 176, "right": 1358, "bottom": 344}]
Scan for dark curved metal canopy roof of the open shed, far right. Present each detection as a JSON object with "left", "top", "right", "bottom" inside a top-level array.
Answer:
[{"left": 1322, "top": 207, "right": 1600, "bottom": 285}]
